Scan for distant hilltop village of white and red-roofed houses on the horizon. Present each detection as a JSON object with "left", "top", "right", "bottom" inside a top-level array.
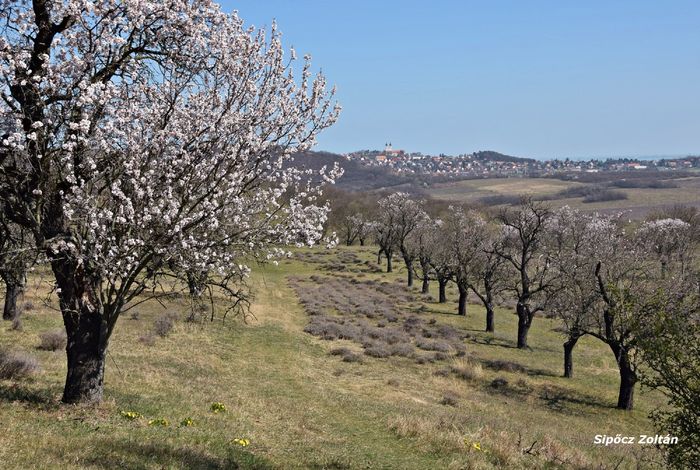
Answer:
[{"left": 344, "top": 143, "right": 700, "bottom": 178}]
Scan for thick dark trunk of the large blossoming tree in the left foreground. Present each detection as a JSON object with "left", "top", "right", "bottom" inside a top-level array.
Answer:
[{"left": 52, "top": 253, "right": 113, "bottom": 403}]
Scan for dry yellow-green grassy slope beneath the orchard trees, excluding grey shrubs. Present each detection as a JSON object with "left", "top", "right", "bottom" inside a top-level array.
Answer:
[{"left": 0, "top": 247, "right": 660, "bottom": 469}]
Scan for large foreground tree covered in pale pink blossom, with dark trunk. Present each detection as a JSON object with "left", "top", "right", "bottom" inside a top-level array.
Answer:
[{"left": 0, "top": 0, "right": 338, "bottom": 403}]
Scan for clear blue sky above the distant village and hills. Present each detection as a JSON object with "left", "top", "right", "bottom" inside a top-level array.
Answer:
[{"left": 223, "top": 0, "right": 700, "bottom": 158}]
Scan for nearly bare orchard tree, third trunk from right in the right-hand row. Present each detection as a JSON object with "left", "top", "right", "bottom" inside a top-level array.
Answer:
[{"left": 496, "top": 198, "right": 555, "bottom": 348}]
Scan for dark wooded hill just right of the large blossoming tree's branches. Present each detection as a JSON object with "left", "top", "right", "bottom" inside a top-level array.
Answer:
[{"left": 293, "top": 152, "right": 415, "bottom": 191}]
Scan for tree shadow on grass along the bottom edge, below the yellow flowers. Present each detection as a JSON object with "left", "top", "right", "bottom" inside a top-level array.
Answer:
[{"left": 65, "top": 438, "right": 275, "bottom": 470}]
